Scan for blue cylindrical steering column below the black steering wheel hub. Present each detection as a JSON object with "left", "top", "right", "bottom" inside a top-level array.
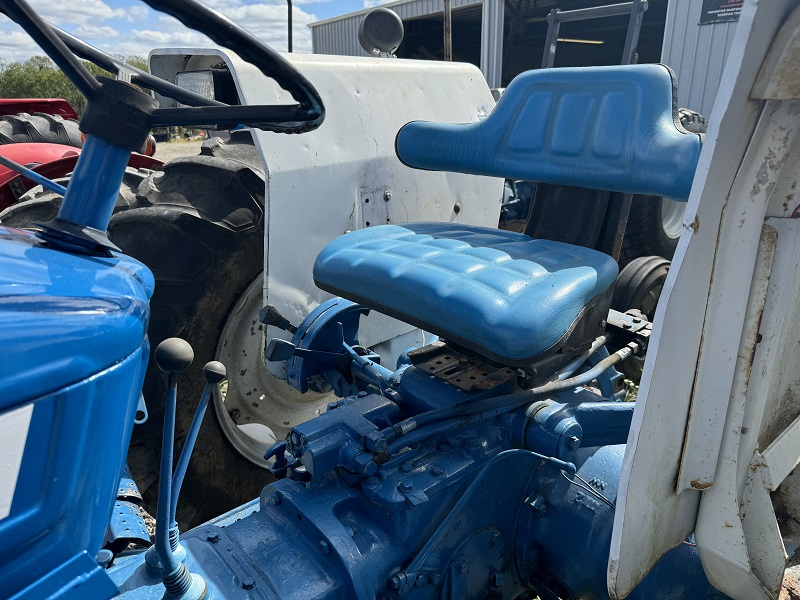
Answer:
[{"left": 58, "top": 135, "right": 131, "bottom": 231}]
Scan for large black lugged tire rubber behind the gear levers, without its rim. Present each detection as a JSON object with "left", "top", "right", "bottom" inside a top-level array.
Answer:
[{"left": 0, "top": 131, "right": 272, "bottom": 529}]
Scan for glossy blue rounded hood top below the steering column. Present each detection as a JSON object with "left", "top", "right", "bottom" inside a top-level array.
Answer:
[{"left": 0, "top": 228, "right": 153, "bottom": 410}]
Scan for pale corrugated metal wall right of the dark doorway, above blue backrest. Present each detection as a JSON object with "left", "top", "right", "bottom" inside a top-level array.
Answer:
[{"left": 661, "top": 0, "right": 736, "bottom": 117}]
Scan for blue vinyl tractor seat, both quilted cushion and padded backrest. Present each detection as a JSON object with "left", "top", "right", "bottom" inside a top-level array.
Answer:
[{"left": 314, "top": 65, "right": 701, "bottom": 366}]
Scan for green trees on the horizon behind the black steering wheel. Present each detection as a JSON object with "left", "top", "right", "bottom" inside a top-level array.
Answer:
[{"left": 0, "top": 56, "right": 147, "bottom": 114}]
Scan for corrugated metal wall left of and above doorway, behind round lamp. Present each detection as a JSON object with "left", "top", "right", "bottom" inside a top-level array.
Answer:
[{"left": 310, "top": 0, "right": 482, "bottom": 56}]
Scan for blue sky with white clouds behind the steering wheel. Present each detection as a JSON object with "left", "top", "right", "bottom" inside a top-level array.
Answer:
[{"left": 0, "top": 0, "right": 396, "bottom": 62}]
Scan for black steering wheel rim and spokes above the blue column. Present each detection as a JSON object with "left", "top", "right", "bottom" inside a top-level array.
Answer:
[{"left": 0, "top": 0, "right": 325, "bottom": 133}]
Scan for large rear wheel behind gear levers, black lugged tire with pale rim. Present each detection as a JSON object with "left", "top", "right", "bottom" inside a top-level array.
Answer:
[{"left": 0, "top": 131, "right": 328, "bottom": 528}]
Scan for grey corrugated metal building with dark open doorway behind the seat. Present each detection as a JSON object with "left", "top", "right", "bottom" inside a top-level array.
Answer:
[{"left": 309, "top": 0, "right": 736, "bottom": 115}]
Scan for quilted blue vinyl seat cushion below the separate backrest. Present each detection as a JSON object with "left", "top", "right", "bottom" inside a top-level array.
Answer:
[{"left": 314, "top": 223, "right": 618, "bottom": 364}]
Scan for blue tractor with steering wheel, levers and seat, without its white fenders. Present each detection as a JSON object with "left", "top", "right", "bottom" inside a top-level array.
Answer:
[{"left": 0, "top": 0, "right": 796, "bottom": 600}]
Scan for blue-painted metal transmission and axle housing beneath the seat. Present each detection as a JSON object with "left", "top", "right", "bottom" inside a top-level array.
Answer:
[{"left": 104, "top": 376, "right": 721, "bottom": 600}]
